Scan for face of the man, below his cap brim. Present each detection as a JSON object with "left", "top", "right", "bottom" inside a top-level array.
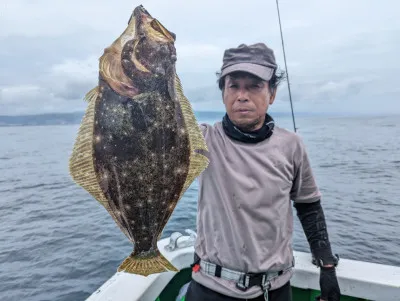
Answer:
[{"left": 223, "top": 73, "right": 276, "bottom": 131}]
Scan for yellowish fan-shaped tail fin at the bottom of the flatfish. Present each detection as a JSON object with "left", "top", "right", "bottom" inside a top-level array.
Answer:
[{"left": 118, "top": 252, "right": 179, "bottom": 276}]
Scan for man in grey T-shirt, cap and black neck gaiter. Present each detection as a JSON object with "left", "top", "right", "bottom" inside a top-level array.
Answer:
[{"left": 186, "top": 43, "right": 340, "bottom": 301}]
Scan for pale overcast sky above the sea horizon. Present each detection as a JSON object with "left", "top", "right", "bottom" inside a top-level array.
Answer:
[{"left": 0, "top": 0, "right": 400, "bottom": 115}]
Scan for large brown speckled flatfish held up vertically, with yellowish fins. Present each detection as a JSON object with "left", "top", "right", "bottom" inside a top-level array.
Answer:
[{"left": 69, "top": 5, "right": 209, "bottom": 276}]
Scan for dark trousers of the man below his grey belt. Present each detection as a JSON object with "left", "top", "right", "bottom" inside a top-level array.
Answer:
[{"left": 185, "top": 280, "right": 292, "bottom": 301}]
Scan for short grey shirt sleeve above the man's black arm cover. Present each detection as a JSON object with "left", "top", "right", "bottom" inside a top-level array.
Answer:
[{"left": 290, "top": 136, "right": 321, "bottom": 203}]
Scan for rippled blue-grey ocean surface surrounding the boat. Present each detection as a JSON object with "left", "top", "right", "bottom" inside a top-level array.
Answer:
[{"left": 0, "top": 115, "right": 400, "bottom": 301}]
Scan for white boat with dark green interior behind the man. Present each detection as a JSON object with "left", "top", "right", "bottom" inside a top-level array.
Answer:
[{"left": 86, "top": 229, "right": 400, "bottom": 301}]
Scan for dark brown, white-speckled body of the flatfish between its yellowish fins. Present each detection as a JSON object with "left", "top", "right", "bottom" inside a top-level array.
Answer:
[{"left": 94, "top": 79, "right": 190, "bottom": 251}]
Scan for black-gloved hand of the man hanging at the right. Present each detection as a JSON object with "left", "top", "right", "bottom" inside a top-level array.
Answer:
[{"left": 316, "top": 265, "right": 340, "bottom": 301}]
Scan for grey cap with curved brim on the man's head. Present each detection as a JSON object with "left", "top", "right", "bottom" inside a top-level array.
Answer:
[{"left": 221, "top": 43, "right": 277, "bottom": 81}]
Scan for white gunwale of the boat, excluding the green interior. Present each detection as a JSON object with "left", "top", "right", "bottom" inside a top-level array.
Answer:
[{"left": 87, "top": 229, "right": 400, "bottom": 301}]
